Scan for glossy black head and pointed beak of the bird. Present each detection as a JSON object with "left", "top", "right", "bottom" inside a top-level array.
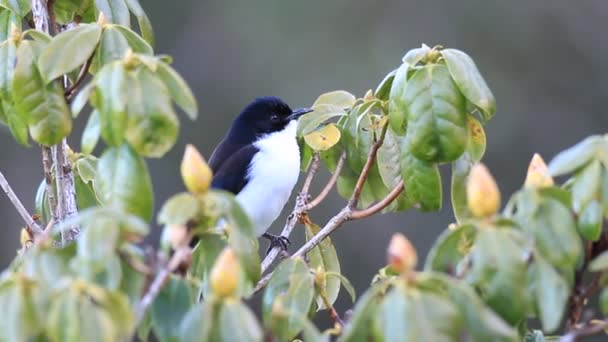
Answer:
[{"left": 235, "top": 96, "right": 312, "bottom": 136}]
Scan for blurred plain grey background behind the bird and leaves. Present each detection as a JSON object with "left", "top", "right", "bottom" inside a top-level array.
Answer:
[{"left": 0, "top": 0, "right": 608, "bottom": 324}]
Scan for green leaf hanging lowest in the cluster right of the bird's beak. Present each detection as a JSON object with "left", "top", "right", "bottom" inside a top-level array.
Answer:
[{"left": 401, "top": 149, "right": 442, "bottom": 211}]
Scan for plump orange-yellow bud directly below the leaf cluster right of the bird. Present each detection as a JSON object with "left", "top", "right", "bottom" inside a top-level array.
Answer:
[{"left": 467, "top": 163, "right": 500, "bottom": 217}]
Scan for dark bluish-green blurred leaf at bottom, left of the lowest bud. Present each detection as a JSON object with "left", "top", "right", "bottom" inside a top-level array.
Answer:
[{"left": 151, "top": 277, "right": 193, "bottom": 341}]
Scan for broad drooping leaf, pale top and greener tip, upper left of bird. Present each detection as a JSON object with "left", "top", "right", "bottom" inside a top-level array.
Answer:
[{"left": 126, "top": 68, "right": 179, "bottom": 158}]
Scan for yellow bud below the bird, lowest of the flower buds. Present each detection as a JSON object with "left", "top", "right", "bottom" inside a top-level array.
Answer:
[{"left": 210, "top": 247, "right": 241, "bottom": 297}]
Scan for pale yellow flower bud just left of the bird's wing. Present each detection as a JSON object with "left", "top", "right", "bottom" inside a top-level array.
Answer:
[{"left": 181, "top": 144, "right": 212, "bottom": 194}]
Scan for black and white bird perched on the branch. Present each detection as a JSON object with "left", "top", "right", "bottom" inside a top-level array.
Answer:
[{"left": 209, "top": 97, "right": 312, "bottom": 250}]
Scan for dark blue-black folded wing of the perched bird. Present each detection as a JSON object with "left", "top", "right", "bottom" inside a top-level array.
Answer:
[{"left": 211, "top": 145, "right": 259, "bottom": 194}]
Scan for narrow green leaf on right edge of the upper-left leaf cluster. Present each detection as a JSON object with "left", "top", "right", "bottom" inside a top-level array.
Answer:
[{"left": 156, "top": 62, "right": 198, "bottom": 120}]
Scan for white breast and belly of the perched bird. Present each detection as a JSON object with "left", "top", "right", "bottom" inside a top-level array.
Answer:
[{"left": 236, "top": 120, "right": 300, "bottom": 235}]
